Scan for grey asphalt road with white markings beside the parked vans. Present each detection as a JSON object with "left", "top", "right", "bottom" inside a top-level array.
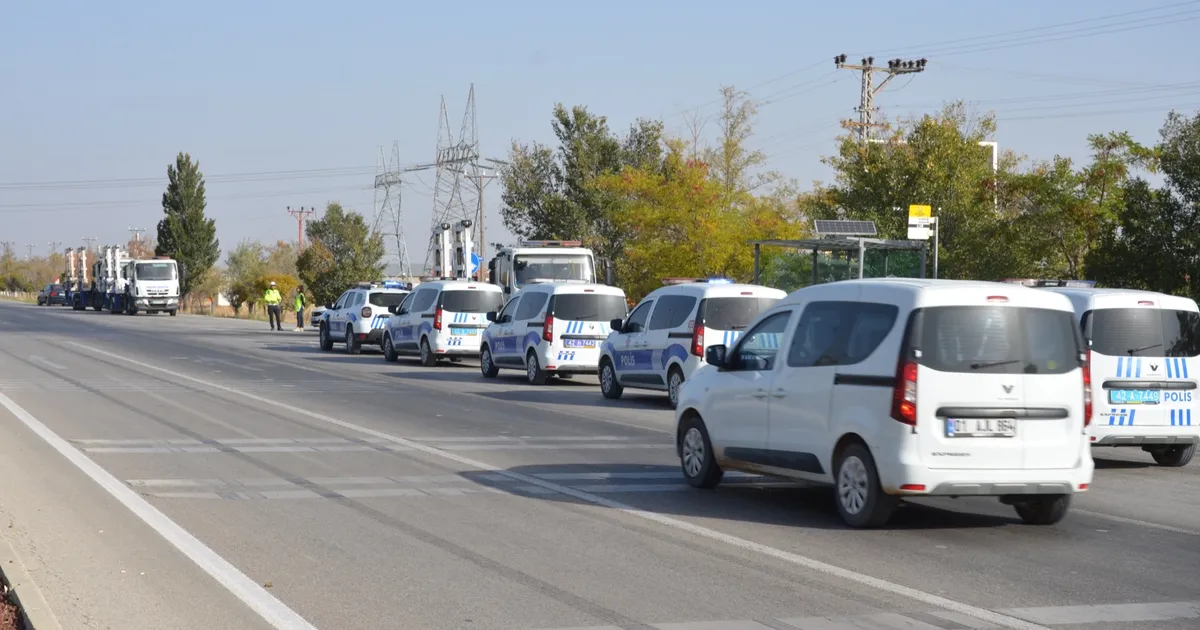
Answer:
[{"left": 0, "top": 304, "right": 1200, "bottom": 630}]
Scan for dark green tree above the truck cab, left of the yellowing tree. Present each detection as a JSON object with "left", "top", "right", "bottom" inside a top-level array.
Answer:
[{"left": 500, "top": 104, "right": 664, "bottom": 258}]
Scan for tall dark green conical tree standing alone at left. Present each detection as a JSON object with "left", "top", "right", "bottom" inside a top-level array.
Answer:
[{"left": 155, "top": 152, "right": 221, "bottom": 295}]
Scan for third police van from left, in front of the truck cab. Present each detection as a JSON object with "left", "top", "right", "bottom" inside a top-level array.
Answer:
[{"left": 479, "top": 281, "right": 628, "bottom": 385}]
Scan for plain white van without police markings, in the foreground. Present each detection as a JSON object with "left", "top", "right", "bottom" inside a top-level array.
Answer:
[{"left": 676, "top": 278, "right": 1094, "bottom": 527}]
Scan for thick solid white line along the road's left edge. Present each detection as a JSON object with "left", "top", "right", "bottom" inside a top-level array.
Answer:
[{"left": 0, "top": 394, "right": 317, "bottom": 630}]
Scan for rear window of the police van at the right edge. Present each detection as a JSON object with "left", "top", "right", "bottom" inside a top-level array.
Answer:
[{"left": 1084, "top": 308, "right": 1200, "bottom": 356}]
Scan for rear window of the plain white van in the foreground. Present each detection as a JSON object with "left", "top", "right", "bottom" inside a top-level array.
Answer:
[{"left": 910, "top": 306, "right": 1082, "bottom": 374}]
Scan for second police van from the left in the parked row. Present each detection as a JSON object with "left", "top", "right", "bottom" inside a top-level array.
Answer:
[{"left": 383, "top": 278, "right": 504, "bottom": 367}]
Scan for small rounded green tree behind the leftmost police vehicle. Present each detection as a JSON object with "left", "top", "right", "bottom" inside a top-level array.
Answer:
[{"left": 296, "top": 202, "right": 384, "bottom": 304}]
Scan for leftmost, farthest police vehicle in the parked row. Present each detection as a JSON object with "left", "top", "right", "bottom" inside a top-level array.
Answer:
[{"left": 317, "top": 281, "right": 408, "bottom": 354}]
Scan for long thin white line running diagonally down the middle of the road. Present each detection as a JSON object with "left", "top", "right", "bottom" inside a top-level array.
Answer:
[{"left": 67, "top": 341, "right": 1048, "bottom": 630}]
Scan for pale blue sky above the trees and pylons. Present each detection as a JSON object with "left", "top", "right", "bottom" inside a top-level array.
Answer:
[{"left": 0, "top": 0, "right": 1200, "bottom": 263}]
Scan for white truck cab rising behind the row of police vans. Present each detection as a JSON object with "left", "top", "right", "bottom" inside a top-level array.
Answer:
[{"left": 487, "top": 240, "right": 612, "bottom": 295}]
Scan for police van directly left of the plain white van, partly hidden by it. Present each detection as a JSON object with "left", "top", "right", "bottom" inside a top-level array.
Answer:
[{"left": 600, "top": 278, "right": 787, "bottom": 406}]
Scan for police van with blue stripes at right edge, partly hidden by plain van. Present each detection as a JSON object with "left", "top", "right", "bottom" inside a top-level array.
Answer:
[{"left": 1043, "top": 288, "right": 1200, "bottom": 467}]
